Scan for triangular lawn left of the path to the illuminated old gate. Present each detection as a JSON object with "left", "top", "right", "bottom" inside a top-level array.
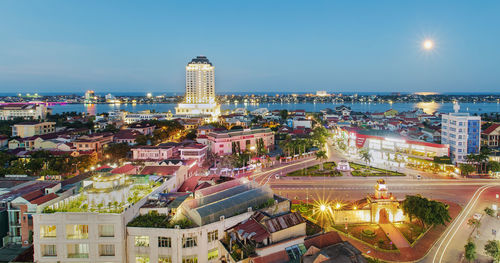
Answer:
[{"left": 333, "top": 224, "right": 396, "bottom": 250}]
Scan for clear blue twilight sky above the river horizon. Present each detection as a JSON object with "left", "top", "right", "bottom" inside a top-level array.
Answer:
[{"left": 0, "top": 0, "right": 500, "bottom": 93}]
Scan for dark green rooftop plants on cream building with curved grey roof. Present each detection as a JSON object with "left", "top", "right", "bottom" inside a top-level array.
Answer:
[{"left": 127, "top": 211, "right": 196, "bottom": 229}]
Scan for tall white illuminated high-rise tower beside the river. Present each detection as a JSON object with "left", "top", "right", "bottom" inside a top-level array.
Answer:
[{"left": 175, "top": 56, "right": 220, "bottom": 118}]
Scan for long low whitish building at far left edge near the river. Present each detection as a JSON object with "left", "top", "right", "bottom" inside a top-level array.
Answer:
[{"left": 0, "top": 103, "right": 50, "bottom": 120}]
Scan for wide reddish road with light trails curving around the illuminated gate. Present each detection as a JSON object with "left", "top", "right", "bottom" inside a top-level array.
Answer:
[{"left": 248, "top": 147, "right": 500, "bottom": 263}]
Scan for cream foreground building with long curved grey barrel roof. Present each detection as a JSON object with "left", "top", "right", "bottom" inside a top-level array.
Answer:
[{"left": 127, "top": 179, "right": 290, "bottom": 263}]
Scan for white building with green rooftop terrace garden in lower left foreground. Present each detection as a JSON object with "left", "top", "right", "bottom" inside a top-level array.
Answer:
[{"left": 33, "top": 175, "right": 176, "bottom": 263}]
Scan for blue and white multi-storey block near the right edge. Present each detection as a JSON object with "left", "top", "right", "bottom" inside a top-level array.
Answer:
[{"left": 441, "top": 104, "right": 481, "bottom": 163}]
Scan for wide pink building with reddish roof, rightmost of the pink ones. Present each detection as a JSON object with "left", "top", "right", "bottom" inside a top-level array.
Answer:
[{"left": 207, "top": 128, "right": 274, "bottom": 154}]
